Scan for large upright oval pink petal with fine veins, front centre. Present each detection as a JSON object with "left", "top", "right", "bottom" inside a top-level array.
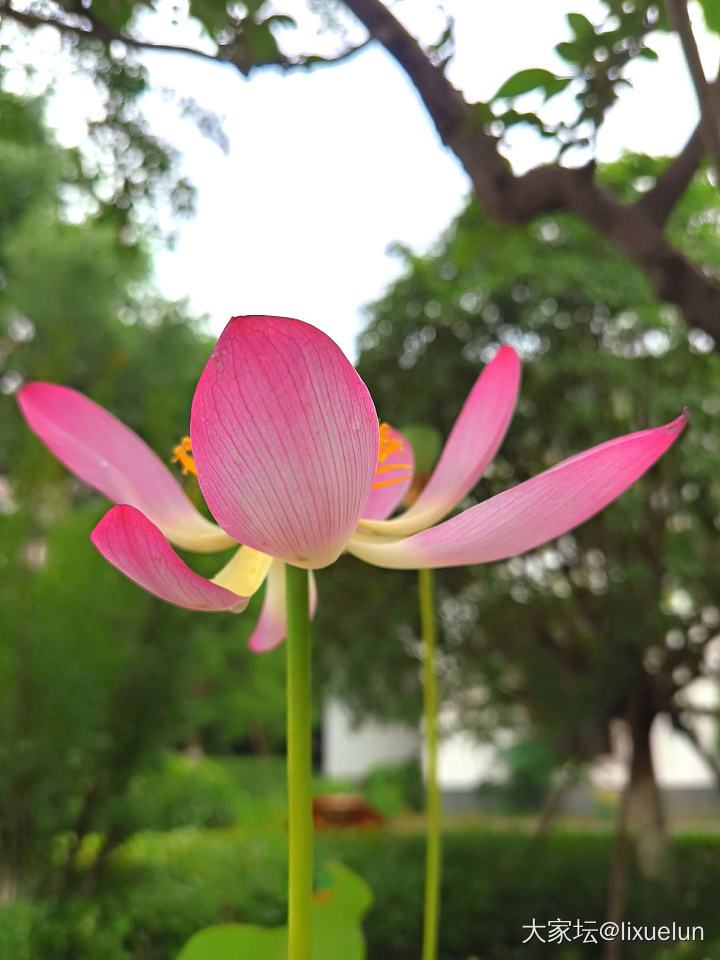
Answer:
[{"left": 190, "top": 316, "right": 378, "bottom": 567}]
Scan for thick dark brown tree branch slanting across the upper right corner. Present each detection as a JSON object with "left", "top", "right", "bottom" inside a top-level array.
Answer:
[{"left": 345, "top": 0, "right": 720, "bottom": 346}]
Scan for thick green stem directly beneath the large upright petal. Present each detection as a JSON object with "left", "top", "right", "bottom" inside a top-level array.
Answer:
[{"left": 285, "top": 564, "right": 313, "bottom": 960}]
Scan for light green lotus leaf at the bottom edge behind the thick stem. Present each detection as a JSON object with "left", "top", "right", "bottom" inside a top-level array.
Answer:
[{"left": 178, "top": 863, "right": 372, "bottom": 960}]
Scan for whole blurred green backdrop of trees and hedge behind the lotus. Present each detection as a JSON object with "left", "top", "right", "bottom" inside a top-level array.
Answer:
[{"left": 0, "top": 1, "right": 720, "bottom": 960}]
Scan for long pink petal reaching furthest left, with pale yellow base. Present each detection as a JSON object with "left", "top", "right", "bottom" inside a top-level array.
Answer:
[{"left": 18, "top": 383, "right": 234, "bottom": 552}]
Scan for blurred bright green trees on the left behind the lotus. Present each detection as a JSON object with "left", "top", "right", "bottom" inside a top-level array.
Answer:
[{"left": 0, "top": 88, "right": 284, "bottom": 900}]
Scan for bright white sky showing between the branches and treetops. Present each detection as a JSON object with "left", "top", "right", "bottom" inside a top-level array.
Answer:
[{"left": 11, "top": 0, "right": 718, "bottom": 357}]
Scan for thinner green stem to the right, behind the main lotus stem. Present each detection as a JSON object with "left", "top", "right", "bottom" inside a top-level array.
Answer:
[{"left": 418, "top": 570, "right": 440, "bottom": 960}]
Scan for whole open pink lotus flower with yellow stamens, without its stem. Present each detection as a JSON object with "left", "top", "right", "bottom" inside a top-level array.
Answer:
[{"left": 19, "top": 316, "right": 686, "bottom": 651}]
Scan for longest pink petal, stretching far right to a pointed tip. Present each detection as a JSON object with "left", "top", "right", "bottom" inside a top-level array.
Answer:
[{"left": 348, "top": 413, "right": 687, "bottom": 570}]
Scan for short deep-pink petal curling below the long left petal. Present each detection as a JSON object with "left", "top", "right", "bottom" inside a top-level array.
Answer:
[{"left": 90, "top": 505, "right": 248, "bottom": 610}]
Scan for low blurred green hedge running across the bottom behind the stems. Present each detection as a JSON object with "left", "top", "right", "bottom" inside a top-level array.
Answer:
[{"left": 7, "top": 824, "right": 720, "bottom": 960}]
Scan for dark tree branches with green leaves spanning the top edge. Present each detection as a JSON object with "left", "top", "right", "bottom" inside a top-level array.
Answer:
[{"left": 7, "top": 0, "right": 720, "bottom": 345}]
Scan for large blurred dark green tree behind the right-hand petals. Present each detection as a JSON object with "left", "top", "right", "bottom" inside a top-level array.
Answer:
[{"left": 319, "top": 156, "right": 720, "bottom": 872}]
